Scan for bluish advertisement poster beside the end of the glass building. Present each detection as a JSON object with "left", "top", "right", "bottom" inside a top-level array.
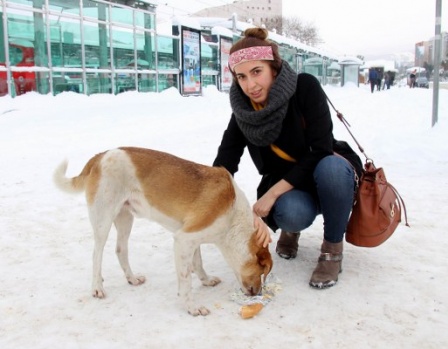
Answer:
[{"left": 182, "top": 28, "right": 201, "bottom": 95}]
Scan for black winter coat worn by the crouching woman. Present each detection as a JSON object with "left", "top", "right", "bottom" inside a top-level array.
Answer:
[{"left": 213, "top": 73, "right": 362, "bottom": 198}]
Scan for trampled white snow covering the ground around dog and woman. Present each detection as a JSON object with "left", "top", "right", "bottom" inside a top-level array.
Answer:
[{"left": 0, "top": 81, "right": 448, "bottom": 349}]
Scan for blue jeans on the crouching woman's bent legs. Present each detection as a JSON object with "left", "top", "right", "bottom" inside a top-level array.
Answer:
[{"left": 273, "top": 155, "right": 355, "bottom": 243}]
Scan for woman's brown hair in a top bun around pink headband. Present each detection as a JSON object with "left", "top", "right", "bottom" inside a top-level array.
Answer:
[{"left": 230, "top": 28, "right": 282, "bottom": 77}]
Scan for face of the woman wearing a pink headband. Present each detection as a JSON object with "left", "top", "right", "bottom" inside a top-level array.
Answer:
[{"left": 235, "top": 61, "right": 277, "bottom": 106}]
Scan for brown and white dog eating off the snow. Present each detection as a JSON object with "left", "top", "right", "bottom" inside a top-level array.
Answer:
[{"left": 54, "top": 147, "right": 272, "bottom": 315}]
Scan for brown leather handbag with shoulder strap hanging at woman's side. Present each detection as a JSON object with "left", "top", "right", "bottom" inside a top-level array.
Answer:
[{"left": 327, "top": 97, "right": 409, "bottom": 247}]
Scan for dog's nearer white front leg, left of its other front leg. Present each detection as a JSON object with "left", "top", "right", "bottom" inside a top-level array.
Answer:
[{"left": 174, "top": 232, "right": 210, "bottom": 316}]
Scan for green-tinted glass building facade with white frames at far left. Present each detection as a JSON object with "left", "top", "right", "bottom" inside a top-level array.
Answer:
[{"left": 0, "top": 0, "right": 179, "bottom": 96}]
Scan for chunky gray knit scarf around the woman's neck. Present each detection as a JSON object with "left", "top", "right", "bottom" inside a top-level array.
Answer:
[{"left": 230, "top": 61, "right": 297, "bottom": 147}]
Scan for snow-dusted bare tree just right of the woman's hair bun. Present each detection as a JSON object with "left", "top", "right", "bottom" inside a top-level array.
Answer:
[{"left": 265, "top": 16, "right": 322, "bottom": 46}]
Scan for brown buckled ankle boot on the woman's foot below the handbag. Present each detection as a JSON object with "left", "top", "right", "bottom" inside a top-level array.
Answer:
[{"left": 310, "top": 240, "right": 342, "bottom": 289}]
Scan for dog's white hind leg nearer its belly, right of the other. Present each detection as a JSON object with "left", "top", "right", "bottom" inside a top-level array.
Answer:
[{"left": 114, "top": 207, "right": 145, "bottom": 286}]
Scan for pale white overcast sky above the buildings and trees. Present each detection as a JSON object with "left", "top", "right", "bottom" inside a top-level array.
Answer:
[{"left": 158, "top": 0, "right": 448, "bottom": 56}]
